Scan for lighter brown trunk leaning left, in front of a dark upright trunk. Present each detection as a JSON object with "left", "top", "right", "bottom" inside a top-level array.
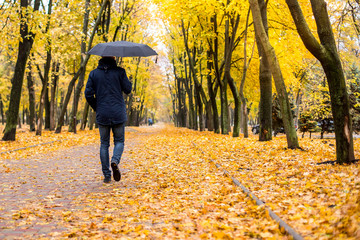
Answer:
[{"left": 249, "top": 0, "right": 299, "bottom": 148}]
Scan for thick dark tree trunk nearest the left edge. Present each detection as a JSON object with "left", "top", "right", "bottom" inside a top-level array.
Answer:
[{"left": 2, "top": 0, "right": 40, "bottom": 141}]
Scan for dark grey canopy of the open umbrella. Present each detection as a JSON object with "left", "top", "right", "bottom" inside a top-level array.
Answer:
[{"left": 88, "top": 41, "right": 157, "bottom": 57}]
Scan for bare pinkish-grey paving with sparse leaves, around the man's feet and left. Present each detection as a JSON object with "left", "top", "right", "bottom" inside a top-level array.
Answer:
[{"left": 0, "top": 138, "right": 134, "bottom": 239}]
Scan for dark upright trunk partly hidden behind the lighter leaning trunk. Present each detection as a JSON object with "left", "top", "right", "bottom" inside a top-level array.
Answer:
[{"left": 256, "top": 0, "right": 272, "bottom": 141}]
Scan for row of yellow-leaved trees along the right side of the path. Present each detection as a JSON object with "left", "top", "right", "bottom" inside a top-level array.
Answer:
[{"left": 157, "top": 0, "right": 360, "bottom": 163}]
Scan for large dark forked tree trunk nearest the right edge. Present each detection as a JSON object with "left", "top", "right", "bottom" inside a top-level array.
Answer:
[{"left": 286, "top": 0, "right": 355, "bottom": 164}]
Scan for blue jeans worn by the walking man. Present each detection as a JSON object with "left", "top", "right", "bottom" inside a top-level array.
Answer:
[{"left": 99, "top": 123, "right": 125, "bottom": 177}]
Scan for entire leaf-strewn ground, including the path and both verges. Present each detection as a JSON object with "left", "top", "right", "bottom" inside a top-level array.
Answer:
[{"left": 0, "top": 126, "right": 360, "bottom": 239}]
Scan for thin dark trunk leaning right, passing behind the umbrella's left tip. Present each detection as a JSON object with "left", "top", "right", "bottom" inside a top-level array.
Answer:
[{"left": 55, "top": 0, "right": 109, "bottom": 133}]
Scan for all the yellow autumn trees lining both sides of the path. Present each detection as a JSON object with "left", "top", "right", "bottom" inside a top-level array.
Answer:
[{"left": 0, "top": 0, "right": 360, "bottom": 163}]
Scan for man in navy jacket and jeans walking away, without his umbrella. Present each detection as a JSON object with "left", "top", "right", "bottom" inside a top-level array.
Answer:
[{"left": 85, "top": 57, "right": 132, "bottom": 183}]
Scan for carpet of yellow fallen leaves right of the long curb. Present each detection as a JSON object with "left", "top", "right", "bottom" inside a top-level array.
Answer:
[{"left": 193, "top": 128, "right": 360, "bottom": 239}]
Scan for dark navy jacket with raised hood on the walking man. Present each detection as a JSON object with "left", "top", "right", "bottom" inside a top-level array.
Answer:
[{"left": 85, "top": 58, "right": 132, "bottom": 125}]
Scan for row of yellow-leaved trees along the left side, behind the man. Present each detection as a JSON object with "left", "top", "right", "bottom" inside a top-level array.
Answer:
[{"left": 0, "top": 0, "right": 161, "bottom": 140}]
